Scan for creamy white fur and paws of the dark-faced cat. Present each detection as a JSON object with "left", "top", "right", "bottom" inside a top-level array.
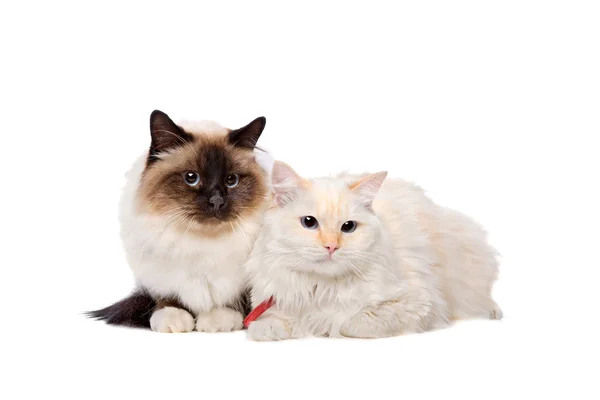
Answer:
[{"left": 120, "top": 121, "right": 270, "bottom": 332}]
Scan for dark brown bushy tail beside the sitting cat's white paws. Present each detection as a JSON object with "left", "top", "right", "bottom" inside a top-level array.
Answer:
[{"left": 85, "top": 289, "right": 156, "bottom": 328}]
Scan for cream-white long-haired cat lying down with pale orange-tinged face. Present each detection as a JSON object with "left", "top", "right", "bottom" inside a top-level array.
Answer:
[{"left": 245, "top": 161, "right": 502, "bottom": 341}]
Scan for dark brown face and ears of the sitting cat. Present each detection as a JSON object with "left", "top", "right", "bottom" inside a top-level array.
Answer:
[{"left": 138, "top": 111, "right": 267, "bottom": 233}]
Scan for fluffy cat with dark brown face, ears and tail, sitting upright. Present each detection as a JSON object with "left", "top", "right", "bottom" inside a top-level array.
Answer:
[{"left": 88, "top": 110, "right": 270, "bottom": 333}]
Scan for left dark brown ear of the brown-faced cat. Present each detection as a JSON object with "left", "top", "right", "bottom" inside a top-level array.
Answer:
[{"left": 149, "top": 110, "right": 193, "bottom": 160}]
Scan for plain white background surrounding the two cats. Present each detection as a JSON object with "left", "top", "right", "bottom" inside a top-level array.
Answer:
[{"left": 0, "top": 0, "right": 600, "bottom": 399}]
